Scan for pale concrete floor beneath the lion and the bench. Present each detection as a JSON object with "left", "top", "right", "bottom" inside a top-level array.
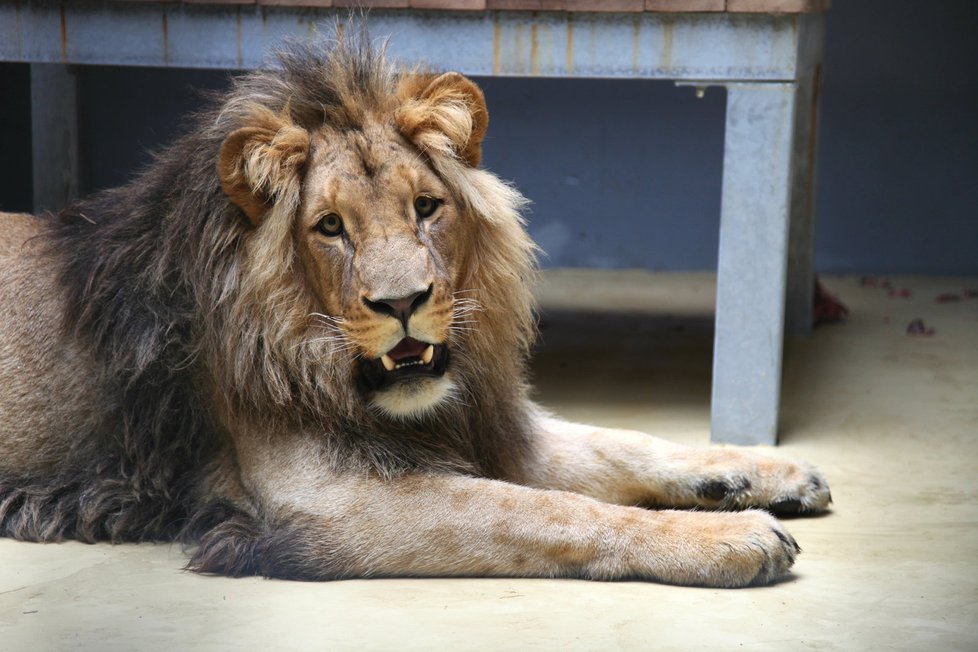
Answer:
[{"left": 0, "top": 271, "right": 978, "bottom": 650}]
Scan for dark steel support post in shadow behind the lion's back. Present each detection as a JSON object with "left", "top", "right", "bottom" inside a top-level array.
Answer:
[{"left": 31, "top": 63, "right": 80, "bottom": 212}]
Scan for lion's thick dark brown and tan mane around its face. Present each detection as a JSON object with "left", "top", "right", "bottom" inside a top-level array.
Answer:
[{"left": 0, "top": 34, "right": 534, "bottom": 575}]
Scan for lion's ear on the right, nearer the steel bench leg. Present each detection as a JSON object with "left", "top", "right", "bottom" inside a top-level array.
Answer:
[{"left": 395, "top": 72, "right": 489, "bottom": 167}]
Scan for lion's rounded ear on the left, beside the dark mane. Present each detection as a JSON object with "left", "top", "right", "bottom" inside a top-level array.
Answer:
[{"left": 217, "top": 109, "right": 309, "bottom": 225}]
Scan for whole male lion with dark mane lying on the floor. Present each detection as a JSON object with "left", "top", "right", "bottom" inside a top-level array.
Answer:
[{"left": 0, "top": 36, "right": 830, "bottom": 587}]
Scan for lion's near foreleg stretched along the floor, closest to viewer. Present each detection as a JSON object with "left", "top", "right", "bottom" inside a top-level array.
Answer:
[{"left": 210, "top": 474, "right": 797, "bottom": 586}]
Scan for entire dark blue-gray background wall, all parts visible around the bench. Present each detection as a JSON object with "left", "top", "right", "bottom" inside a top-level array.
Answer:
[{"left": 0, "top": 0, "right": 978, "bottom": 274}]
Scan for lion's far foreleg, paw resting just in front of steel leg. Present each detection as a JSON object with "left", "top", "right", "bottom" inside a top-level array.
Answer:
[{"left": 519, "top": 416, "right": 830, "bottom": 512}]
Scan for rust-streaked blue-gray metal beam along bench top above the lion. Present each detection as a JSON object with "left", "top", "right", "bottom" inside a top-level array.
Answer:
[{"left": 0, "top": 3, "right": 806, "bottom": 81}]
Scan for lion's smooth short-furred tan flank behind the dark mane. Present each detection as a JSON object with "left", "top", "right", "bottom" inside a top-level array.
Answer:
[{"left": 0, "top": 213, "right": 107, "bottom": 474}]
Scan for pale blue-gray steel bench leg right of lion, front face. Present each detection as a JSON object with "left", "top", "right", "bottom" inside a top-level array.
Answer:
[{"left": 712, "top": 83, "right": 796, "bottom": 445}]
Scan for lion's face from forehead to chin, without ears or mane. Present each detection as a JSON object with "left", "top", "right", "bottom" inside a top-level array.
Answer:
[{"left": 295, "top": 123, "right": 462, "bottom": 416}]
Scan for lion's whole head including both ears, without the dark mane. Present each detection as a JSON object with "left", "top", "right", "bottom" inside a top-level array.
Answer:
[{"left": 218, "top": 73, "right": 500, "bottom": 418}]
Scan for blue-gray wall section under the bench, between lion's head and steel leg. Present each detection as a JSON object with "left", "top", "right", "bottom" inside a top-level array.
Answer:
[{"left": 480, "top": 79, "right": 725, "bottom": 269}]
